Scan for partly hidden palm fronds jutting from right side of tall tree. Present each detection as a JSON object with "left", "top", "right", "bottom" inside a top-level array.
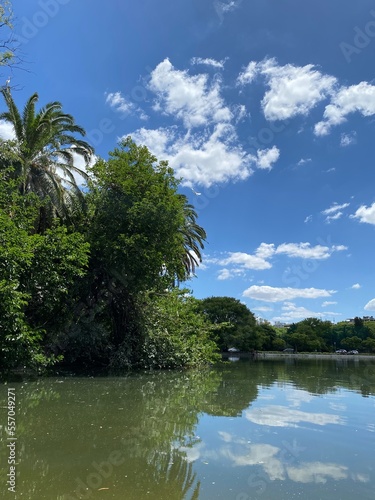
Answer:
[{"left": 179, "top": 195, "right": 207, "bottom": 276}]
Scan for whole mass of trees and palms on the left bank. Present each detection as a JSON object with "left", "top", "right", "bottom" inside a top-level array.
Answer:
[{"left": 0, "top": 87, "right": 216, "bottom": 371}]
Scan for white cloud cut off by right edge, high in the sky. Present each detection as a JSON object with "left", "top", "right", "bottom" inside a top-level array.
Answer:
[{"left": 314, "top": 82, "right": 375, "bottom": 136}]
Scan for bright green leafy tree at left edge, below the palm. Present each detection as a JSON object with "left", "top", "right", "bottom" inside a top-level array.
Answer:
[{"left": 0, "top": 164, "right": 88, "bottom": 370}]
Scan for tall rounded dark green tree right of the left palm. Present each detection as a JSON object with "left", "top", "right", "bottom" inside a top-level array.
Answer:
[{"left": 66, "top": 138, "right": 207, "bottom": 366}]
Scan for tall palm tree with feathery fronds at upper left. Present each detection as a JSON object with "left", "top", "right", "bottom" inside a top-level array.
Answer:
[{"left": 0, "top": 87, "right": 94, "bottom": 229}]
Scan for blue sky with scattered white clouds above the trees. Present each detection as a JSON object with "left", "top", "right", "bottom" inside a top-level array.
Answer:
[{"left": 0, "top": 0, "right": 375, "bottom": 323}]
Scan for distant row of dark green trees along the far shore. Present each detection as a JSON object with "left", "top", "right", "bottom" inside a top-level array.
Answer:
[{"left": 200, "top": 297, "right": 375, "bottom": 353}]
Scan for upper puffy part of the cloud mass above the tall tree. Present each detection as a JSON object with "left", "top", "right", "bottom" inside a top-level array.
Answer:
[{"left": 149, "top": 59, "right": 232, "bottom": 129}]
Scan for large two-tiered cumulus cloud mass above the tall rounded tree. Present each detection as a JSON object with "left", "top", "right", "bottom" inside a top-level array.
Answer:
[{"left": 126, "top": 58, "right": 280, "bottom": 187}]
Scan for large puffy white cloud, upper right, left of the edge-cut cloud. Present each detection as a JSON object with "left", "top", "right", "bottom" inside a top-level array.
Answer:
[{"left": 237, "top": 59, "right": 337, "bottom": 121}]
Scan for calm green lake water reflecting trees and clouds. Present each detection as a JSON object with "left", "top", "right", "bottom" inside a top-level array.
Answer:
[{"left": 0, "top": 357, "right": 375, "bottom": 500}]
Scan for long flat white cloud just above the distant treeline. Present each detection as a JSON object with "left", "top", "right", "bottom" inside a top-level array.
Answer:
[{"left": 242, "top": 285, "right": 336, "bottom": 302}]
